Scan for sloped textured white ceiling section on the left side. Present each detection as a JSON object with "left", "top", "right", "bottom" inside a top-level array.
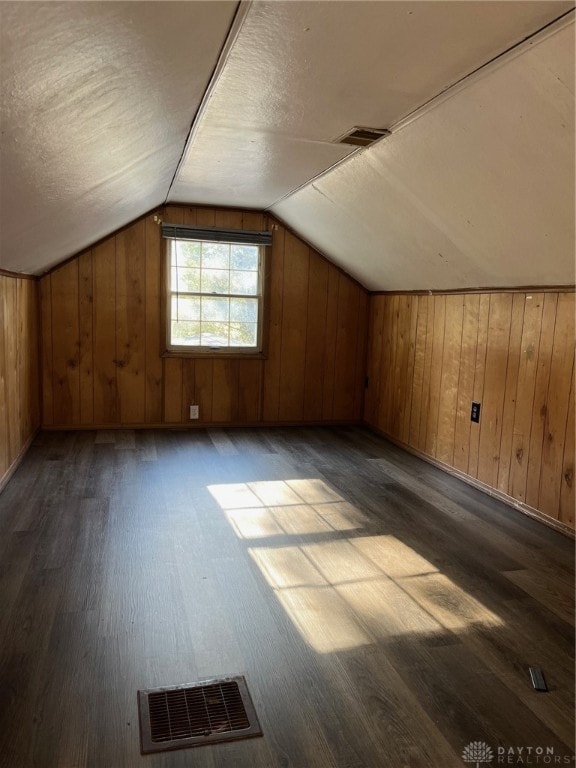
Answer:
[{"left": 0, "top": 2, "right": 238, "bottom": 273}]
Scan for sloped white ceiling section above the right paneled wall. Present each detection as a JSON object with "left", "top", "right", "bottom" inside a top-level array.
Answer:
[{"left": 273, "top": 23, "right": 575, "bottom": 290}]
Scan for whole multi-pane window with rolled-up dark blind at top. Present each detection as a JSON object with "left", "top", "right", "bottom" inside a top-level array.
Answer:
[{"left": 162, "top": 225, "right": 271, "bottom": 355}]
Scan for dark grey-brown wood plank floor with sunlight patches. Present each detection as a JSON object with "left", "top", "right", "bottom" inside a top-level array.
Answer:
[{"left": 0, "top": 428, "right": 574, "bottom": 768}]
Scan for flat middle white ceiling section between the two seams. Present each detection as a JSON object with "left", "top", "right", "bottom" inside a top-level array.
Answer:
[{"left": 170, "top": 0, "right": 570, "bottom": 210}]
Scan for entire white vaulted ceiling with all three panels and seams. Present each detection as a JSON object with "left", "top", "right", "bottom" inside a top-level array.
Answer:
[{"left": 0, "top": 0, "right": 575, "bottom": 290}]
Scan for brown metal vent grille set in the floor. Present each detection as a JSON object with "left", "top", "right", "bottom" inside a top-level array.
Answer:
[{"left": 138, "top": 677, "right": 262, "bottom": 754}]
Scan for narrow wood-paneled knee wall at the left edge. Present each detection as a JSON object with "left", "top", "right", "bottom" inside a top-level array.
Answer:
[{"left": 0, "top": 275, "right": 40, "bottom": 488}]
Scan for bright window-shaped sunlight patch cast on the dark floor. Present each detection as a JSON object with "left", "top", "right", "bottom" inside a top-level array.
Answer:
[{"left": 209, "top": 479, "right": 502, "bottom": 653}]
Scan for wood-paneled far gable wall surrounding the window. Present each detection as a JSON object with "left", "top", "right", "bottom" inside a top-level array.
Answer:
[{"left": 41, "top": 206, "right": 368, "bottom": 427}]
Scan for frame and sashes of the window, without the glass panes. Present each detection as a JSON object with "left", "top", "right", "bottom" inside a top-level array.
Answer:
[{"left": 163, "top": 235, "right": 267, "bottom": 358}]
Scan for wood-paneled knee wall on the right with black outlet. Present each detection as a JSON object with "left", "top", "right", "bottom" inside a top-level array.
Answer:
[{"left": 365, "top": 292, "right": 575, "bottom": 527}]
